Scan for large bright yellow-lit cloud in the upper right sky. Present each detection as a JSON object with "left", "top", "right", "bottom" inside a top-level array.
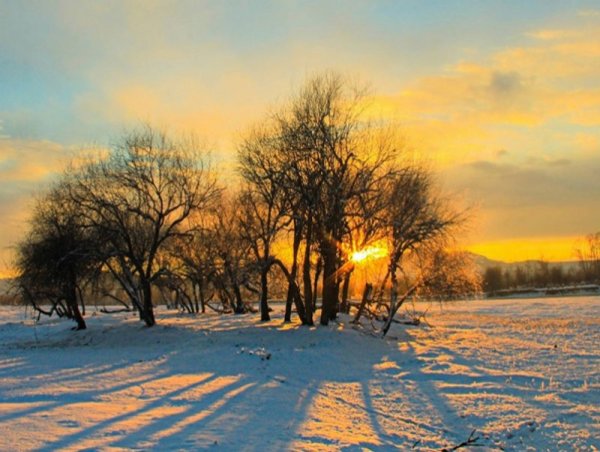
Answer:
[{"left": 364, "top": 11, "right": 600, "bottom": 177}]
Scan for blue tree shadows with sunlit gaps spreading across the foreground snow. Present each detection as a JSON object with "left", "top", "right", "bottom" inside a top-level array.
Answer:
[{"left": 0, "top": 315, "right": 544, "bottom": 450}]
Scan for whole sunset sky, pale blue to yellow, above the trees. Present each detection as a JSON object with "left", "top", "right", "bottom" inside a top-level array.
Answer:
[{"left": 0, "top": 0, "right": 600, "bottom": 273}]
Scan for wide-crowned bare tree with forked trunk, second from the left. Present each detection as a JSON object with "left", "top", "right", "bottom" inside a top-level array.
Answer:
[{"left": 70, "top": 126, "right": 218, "bottom": 326}]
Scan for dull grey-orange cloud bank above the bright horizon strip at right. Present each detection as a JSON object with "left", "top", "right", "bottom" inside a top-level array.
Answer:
[{"left": 441, "top": 154, "right": 600, "bottom": 241}]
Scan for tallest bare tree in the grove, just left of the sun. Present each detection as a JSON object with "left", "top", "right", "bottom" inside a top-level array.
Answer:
[{"left": 276, "top": 74, "right": 395, "bottom": 325}]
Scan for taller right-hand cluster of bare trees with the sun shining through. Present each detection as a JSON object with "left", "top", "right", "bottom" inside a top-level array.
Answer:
[{"left": 239, "top": 74, "right": 477, "bottom": 332}]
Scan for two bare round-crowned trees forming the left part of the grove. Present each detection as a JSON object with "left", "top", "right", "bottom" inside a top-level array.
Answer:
[{"left": 17, "top": 127, "right": 218, "bottom": 329}]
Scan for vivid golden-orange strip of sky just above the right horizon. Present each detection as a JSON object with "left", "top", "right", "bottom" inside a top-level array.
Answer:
[{"left": 466, "top": 237, "right": 580, "bottom": 262}]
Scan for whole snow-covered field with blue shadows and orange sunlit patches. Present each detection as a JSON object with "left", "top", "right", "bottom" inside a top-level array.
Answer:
[{"left": 0, "top": 297, "right": 600, "bottom": 450}]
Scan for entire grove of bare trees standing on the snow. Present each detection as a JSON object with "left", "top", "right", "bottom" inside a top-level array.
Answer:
[{"left": 18, "top": 74, "right": 477, "bottom": 328}]
